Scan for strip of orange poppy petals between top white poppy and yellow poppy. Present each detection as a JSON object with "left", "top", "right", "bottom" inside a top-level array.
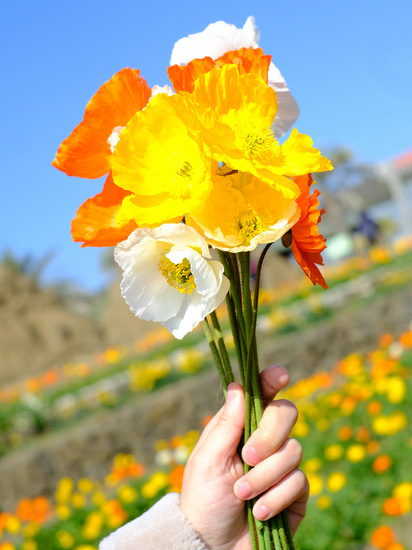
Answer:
[{"left": 167, "top": 48, "right": 272, "bottom": 92}]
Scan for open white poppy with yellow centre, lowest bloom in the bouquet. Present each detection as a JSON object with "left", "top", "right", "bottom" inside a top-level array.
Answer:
[{"left": 114, "top": 224, "right": 229, "bottom": 339}]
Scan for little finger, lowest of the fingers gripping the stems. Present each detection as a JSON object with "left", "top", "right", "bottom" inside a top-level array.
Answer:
[{"left": 253, "top": 469, "right": 309, "bottom": 522}]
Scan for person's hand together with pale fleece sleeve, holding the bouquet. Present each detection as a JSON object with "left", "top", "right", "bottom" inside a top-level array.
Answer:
[{"left": 99, "top": 367, "right": 309, "bottom": 550}]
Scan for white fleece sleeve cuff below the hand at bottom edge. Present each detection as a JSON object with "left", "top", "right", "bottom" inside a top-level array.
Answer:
[{"left": 99, "top": 493, "right": 209, "bottom": 550}]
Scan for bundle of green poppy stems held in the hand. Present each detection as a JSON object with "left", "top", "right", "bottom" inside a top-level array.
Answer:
[{"left": 203, "top": 248, "right": 295, "bottom": 550}]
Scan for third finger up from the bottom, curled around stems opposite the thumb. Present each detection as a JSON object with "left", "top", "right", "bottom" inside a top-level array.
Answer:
[{"left": 242, "top": 399, "right": 298, "bottom": 466}]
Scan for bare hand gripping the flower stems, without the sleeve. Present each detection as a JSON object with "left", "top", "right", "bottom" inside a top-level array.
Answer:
[{"left": 181, "top": 367, "right": 309, "bottom": 550}]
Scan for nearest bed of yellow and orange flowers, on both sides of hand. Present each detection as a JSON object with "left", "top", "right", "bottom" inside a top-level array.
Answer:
[{"left": 0, "top": 330, "right": 412, "bottom": 550}]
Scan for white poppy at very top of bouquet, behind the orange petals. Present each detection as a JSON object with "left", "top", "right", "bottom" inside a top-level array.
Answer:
[{"left": 170, "top": 16, "right": 299, "bottom": 138}]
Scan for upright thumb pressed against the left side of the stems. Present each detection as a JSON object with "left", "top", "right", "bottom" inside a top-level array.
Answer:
[{"left": 202, "top": 383, "right": 245, "bottom": 461}]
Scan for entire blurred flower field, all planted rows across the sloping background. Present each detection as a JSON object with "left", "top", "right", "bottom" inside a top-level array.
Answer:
[{"left": 0, "top": 243, "right": 412, "bottom": 550}]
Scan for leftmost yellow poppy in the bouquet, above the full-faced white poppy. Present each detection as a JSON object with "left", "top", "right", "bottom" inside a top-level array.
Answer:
[{"left": 111, "top": 94, "right": 217, "bottom": 227}]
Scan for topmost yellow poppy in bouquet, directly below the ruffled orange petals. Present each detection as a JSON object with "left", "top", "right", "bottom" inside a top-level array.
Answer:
[{"left": 180, "top": 64, "right": 332, "bottom": 199}]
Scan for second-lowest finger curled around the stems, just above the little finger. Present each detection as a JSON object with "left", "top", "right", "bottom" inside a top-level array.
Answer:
[{"left": 234, "top": 439, "right": 303, "bottom": 500}]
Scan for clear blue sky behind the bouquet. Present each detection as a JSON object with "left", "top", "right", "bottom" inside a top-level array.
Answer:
[{"left": 0, "top": 0, "right": 412, "bottom": 289}]
